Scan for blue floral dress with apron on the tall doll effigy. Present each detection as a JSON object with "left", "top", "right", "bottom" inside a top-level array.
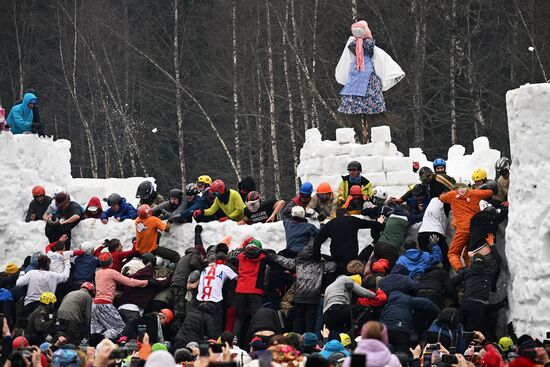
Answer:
[{"left": 338, "top": 38, "right": 386, "bottom": 115}]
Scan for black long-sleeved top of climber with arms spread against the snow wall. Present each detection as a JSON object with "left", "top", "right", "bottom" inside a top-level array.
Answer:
[{"left": 313, "top": 215, "right": 382, "bottom": 264}]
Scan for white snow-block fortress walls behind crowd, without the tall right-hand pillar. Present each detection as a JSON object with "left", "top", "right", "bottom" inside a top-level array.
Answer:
[{"left": 0, "top": 126, "right": 500, "bottom": 266}]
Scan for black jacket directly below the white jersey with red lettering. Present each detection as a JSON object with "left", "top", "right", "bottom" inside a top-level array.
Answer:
[{"left": 174, "top": 303, "right": 219, "bottom": 349}]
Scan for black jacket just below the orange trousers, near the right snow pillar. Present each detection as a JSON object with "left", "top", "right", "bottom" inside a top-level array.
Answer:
[{"left": 464, "top": 255, "right": 497, "bottom": 302}]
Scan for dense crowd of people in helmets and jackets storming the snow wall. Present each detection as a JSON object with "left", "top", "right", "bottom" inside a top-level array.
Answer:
[{"left": 0, "top": 151, "right": 548, "bottom": 367}]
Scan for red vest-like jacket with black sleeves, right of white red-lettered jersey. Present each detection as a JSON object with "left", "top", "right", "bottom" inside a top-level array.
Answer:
[{"left": 235, "top": 252, "right": 267, "bottom": 295}]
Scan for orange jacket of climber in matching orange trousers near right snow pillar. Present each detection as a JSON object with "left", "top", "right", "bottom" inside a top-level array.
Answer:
[{"left": 439, "top": 189, "right": 493, "bottom": 231}]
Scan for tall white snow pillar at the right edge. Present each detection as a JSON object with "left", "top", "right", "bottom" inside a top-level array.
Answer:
[{"left": 506, "top": 84, "right": 550, "bottom": 339}]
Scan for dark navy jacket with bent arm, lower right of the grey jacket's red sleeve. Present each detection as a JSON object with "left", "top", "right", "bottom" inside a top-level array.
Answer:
[{"left": 380, "top": 291, "right": 441, "bottom": 334}]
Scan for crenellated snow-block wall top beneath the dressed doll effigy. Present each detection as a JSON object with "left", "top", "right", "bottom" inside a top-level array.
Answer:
[{"left": 297, "top": 126, "right": 500, "bottom": 196}]
